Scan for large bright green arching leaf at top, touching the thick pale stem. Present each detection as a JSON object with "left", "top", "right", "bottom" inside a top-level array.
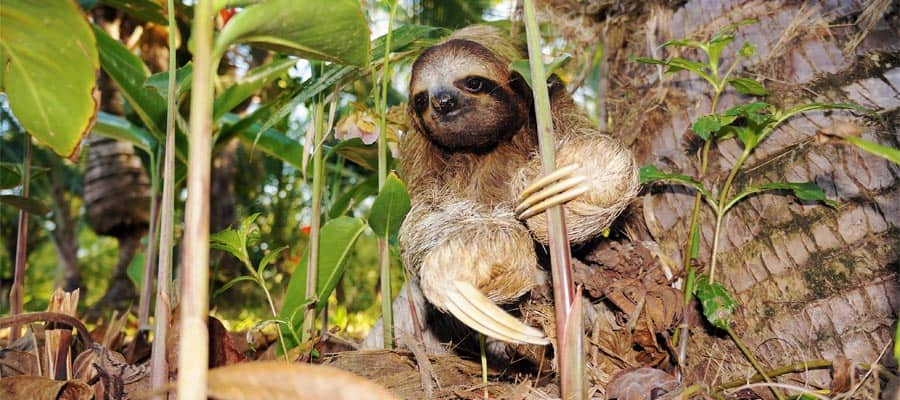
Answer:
[{"left": 213, "top": 0, "right": 369, "bottom": 66}]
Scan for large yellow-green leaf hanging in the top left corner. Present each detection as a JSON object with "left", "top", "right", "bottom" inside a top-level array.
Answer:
[{"left": 0, "top": 1, "right": 99, "bottom": 157}]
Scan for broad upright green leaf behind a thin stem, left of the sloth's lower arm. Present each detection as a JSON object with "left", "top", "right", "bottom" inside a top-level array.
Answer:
[{"left": 278, "top": 217, "right": 366, "bottom": 348}]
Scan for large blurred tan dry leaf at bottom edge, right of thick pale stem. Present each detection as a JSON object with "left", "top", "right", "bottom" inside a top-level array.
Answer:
[{"left": 208, "top": 361, "right": 395, "bottom": 400}]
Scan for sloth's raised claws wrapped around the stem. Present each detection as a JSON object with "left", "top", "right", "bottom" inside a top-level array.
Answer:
[{"left": 516, "top": 164, "right": 589, "bottom": 219}]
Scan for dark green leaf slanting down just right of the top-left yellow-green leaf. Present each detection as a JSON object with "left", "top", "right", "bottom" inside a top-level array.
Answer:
[{"left": 94, "top": 26, "right": 166, "bottom": 140}]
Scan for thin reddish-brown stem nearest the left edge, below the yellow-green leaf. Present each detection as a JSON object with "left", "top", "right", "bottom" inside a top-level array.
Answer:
[{"left": 9, "top": 137, "right": 31, "bottom": 343}]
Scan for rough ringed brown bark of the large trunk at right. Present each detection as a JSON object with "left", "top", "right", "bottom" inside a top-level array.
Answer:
[{"left": 608, "top": 1, "right": 900, "bottom": 384}]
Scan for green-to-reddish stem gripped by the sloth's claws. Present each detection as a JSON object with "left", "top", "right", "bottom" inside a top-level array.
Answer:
[{"left": 525, "top": 0, "right": 586, "bottom": 399}]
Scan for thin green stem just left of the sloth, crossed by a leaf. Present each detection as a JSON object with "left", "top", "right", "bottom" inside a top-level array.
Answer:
[{"left": 377, "top": 1, "right": 400, "bottom": 349}]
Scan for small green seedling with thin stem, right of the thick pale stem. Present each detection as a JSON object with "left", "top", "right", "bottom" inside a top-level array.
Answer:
[{"left": 209, "top": 214, "right": 287, "bottom": 359}]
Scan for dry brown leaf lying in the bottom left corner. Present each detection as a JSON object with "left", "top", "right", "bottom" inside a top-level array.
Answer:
[{"left": 0, "top": 375, "right": 94, "bottom": 400}]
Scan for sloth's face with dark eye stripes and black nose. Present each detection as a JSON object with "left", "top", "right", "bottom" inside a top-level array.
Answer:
[{"left": 409, "top": 39, "right": 528, "bottom": 152}]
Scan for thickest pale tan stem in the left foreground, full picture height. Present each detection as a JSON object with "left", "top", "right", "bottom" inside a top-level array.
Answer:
[{"left": 178, "top": 0, "right": 214, "bottom": 400}]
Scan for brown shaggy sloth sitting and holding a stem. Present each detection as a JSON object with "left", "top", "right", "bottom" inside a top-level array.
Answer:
[{"left": 399, "top": 26, "right": 639, "bottom": 345}]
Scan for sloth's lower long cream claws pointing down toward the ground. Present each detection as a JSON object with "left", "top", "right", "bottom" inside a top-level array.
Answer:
[{"left": 445, "top": 281, "right": 550, "bottom": 345}]
